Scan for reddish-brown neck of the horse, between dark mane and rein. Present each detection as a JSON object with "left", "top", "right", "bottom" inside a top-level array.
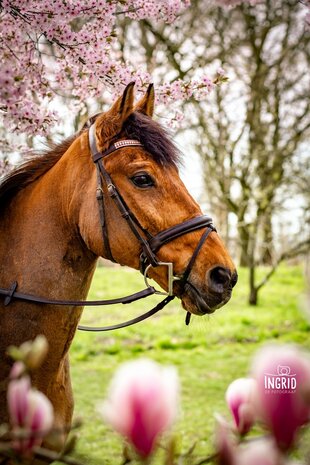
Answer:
[{"left": 0, "top": 132, "right": 97, "bottom": 299}]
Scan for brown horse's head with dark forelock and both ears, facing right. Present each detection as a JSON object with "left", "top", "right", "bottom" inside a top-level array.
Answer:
[{"left": 78, "top": 83, "right": 237, "bottom": 315}]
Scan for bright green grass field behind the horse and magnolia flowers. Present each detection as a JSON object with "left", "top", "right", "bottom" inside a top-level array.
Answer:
[{"left": 71, "top": 266, "right": 310, "bottom": 464}]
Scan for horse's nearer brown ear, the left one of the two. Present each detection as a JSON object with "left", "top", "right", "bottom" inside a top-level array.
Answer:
[{"left": 96, "top": 82, "right": 135, "bottom": 150}]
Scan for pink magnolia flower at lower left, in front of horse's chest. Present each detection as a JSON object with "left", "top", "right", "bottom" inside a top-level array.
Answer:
[{"left": 8, "top": 376, "right": 54, "bottom": 455}]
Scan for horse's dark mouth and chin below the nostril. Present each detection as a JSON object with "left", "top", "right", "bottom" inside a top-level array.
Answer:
[{"left": 181, "top": 282, "right": 231, "bottom": 315}]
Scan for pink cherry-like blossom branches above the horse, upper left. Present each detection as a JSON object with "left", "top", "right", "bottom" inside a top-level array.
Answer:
[{"left": 0, "top": 0, "right": 274, "bottom": 156}]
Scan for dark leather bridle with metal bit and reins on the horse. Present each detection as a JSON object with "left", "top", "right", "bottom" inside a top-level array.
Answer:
[{"left": 0, "top": 123, "right": 216, "bottom": 331}]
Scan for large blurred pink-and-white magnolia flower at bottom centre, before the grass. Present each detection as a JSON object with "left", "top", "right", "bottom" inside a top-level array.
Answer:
[{"left": 101, "top": 360, "right": 179, "bottom": 458}]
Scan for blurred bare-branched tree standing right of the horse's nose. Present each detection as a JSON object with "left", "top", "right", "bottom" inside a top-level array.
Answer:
[{"left": 193, "top": 1, "right": 310, "bottom": 304}]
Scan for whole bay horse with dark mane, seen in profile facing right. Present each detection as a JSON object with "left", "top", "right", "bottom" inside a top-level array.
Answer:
[{"left": 0, "top": 83, "right": 237, "bottom": 442}]
